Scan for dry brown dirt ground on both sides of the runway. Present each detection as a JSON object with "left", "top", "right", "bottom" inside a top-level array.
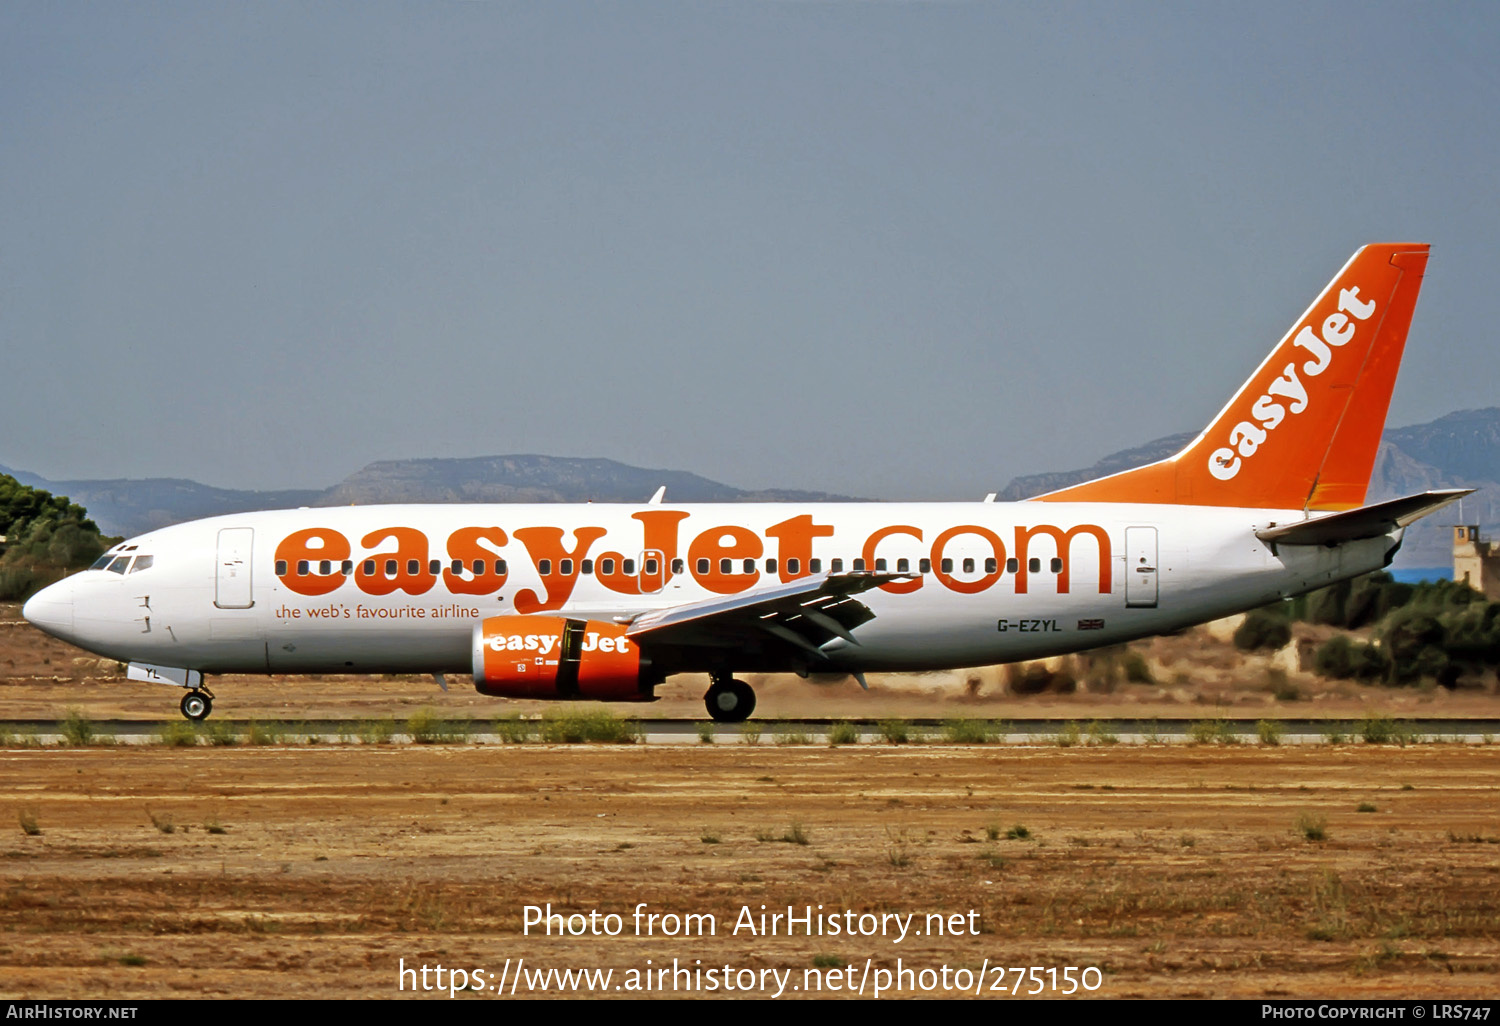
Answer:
[{"left": 0, "top": 609, "right": 1500, "bottom": 1001}]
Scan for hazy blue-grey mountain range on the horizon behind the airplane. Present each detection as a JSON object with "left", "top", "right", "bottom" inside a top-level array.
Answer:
[{"left": 0, "top": 407, "right": 1500, "bottom": 567}]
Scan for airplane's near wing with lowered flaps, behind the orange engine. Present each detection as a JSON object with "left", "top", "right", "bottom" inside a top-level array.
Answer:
[{"left": 626, "top": 573, "right": 912, "bottom": 659}]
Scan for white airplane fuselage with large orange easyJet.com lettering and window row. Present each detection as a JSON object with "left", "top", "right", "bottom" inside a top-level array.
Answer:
[{"left": 26, "top": 501, "right": 1400, "bottom": 674}]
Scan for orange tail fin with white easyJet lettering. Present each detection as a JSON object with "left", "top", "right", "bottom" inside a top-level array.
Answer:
[{"left": 1038, "top": 243, "right": 1428, "bottom": 510}]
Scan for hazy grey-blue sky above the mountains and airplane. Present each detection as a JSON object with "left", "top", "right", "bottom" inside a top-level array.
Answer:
[{"left": 0, "top": 2, "right": 1500, "bottom": 498}]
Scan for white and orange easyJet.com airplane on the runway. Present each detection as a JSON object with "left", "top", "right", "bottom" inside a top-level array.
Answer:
[{"left": 23, "top": 243, "right": 1467, "bottom": 723}]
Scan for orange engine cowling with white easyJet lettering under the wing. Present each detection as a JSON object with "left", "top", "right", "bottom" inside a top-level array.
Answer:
[{"left": 474, "top": 617, "right": 656, "bottom": 702}]
